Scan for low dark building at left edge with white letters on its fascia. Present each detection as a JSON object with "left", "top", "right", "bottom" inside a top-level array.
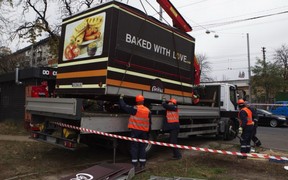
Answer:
[{"left": 0, "top": 67, "right": 57, "bottom": 122}]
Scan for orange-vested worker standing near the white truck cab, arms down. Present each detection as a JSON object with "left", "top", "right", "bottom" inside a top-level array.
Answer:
[{"left": 237, "top": 99, "right": 254, "bottom": 158}]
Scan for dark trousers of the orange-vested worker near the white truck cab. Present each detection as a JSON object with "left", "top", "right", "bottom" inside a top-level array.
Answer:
[{"left": 240, "top": 125, "right": 253, "bottom": 153}]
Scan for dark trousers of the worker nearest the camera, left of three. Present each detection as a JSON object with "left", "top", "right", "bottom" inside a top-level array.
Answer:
[{"left": 130, "top": 129, "right": 148, "bottom": 167}]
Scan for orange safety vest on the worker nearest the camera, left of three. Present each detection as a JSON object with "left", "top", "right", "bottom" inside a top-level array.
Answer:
[{"left": 128, "top": 105, "right": 150, "bottom": 132}]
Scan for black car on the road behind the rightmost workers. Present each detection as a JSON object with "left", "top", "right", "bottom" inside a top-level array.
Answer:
[{"left": 257, "top": 109, "right": 287, "bottom": 127}]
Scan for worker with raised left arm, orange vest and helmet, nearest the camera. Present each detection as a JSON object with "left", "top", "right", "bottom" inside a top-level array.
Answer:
[{"left": 119, "top": 95, "right": 151, "bottom": 169}]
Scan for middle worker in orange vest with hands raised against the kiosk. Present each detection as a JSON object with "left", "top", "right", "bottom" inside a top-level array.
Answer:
[{"left": 162, "top": 98, "right": 182, "bottom": 160}]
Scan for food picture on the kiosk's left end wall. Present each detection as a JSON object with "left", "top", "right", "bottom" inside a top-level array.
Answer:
[{"left": 63, "top": 12, "right": 106, "bottom": 61}]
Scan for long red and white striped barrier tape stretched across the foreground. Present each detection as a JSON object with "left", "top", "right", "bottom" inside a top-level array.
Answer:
[{"left": 53, "top": 122, "right": 288, "bottom": 161}]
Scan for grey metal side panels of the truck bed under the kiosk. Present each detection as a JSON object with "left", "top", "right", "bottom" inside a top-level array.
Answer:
[{"left": 26, "top": 98, "right": 220, "bottom": 135}]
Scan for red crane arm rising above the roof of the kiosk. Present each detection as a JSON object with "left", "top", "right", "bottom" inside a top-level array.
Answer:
[{"left": 157, "top": 0, "right": 192, "bottom": 32}]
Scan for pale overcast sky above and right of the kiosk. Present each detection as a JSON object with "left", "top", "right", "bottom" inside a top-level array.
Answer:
[{"left": 126, "top": 0, "right": 288, "bottom": 80}]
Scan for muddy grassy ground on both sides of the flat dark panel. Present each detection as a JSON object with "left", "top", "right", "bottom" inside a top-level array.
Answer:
[{"left": 0, "top": 136, "right": 288, "bottom": 180}]
